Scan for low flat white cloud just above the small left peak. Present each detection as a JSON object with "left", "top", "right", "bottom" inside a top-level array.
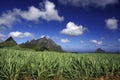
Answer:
[{"left": 9, "top": 31, "right": 34, "bottom": 38}]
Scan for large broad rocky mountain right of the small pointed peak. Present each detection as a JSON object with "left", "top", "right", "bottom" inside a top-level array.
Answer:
[{"left": 21, "top": 37, "right": 63, "bottom": 51}]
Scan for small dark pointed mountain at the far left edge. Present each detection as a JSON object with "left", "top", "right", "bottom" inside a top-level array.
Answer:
[{"left": 0, "top": 36, "right": 17, "bottom": 48}]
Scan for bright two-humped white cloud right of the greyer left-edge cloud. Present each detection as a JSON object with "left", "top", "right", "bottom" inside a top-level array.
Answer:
[{"left": 20, "top": 0, "right": 64, "bottom": 21}]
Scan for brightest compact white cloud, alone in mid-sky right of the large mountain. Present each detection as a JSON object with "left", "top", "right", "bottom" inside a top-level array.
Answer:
[{"left": 61, "top": 22, "right": 87, "bottom": 36}]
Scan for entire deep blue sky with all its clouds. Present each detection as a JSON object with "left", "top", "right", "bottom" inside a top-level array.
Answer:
[{"left": 0, "top": 0, "right": 120, "bottom": 52}]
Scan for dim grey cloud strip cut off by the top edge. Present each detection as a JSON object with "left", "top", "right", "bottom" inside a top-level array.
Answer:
[{"left": 59, "top": 0, "right": 119, "bottom": 7}]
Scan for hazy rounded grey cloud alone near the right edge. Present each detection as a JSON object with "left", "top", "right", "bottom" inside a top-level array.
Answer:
[{"left": 105, "top": 17, "right": 118, "bottom": 30}]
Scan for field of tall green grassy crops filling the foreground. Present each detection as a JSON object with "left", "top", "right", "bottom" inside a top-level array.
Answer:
[{"left": 0, "top": 49, "right": 120, "bottom": 80}]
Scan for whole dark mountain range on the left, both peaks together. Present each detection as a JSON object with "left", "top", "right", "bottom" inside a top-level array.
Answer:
[{"left": 0, "top": 36, "right": 63, "bottom": 52}]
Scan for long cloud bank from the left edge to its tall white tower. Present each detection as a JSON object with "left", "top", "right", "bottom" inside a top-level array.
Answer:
[{"left": 0, "top": 0, "right": 64, "bottom": 27}]
